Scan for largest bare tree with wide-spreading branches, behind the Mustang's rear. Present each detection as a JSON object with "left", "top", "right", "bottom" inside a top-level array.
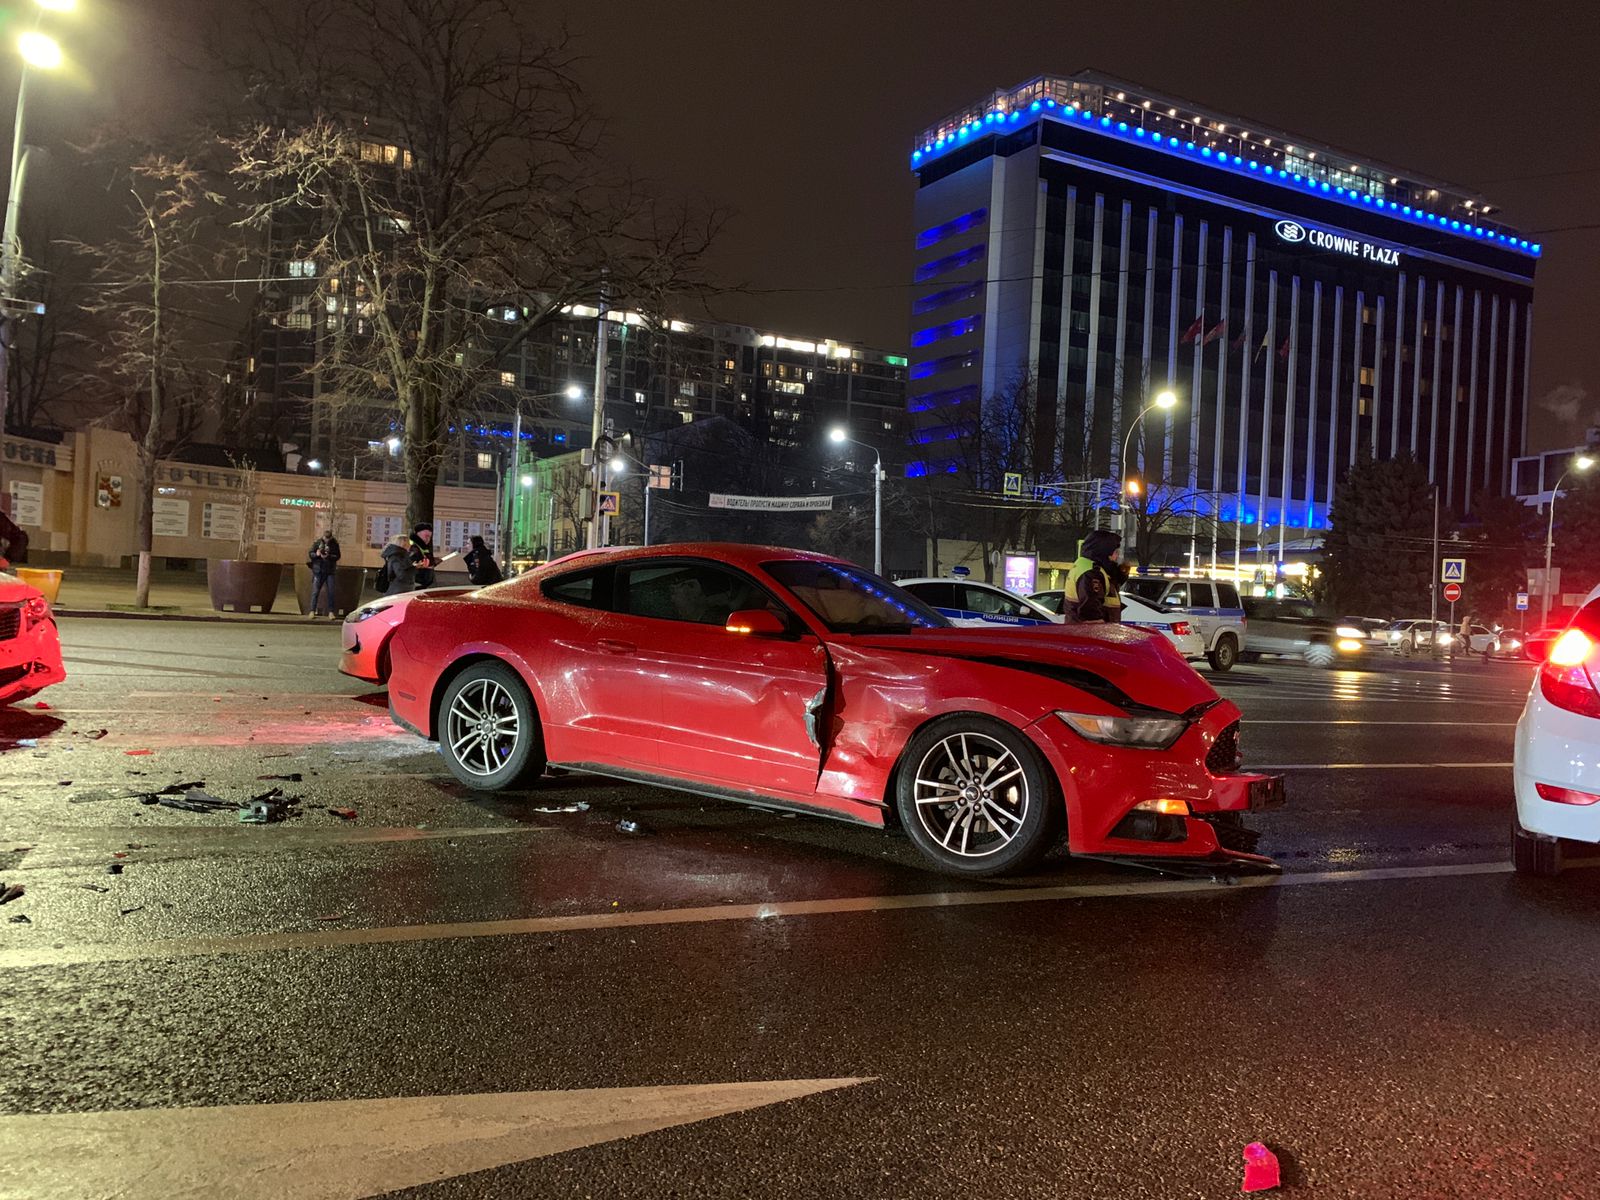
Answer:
[{"left": 229, "top": 0, "right": 720, "bottom": 534}]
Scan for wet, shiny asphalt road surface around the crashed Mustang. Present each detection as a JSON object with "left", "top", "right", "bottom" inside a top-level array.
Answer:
[{"left": 0, "top": 619, "right": 1600, "bottom": 1197}]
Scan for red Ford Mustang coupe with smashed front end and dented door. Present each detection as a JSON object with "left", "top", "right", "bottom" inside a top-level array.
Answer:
[{"left": 380, "top": 544, "right": 1283, "bottom": 875}]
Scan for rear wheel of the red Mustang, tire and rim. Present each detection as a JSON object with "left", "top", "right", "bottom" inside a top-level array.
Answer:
[{"left": 438, "top": 662, "right": 546, "bottom": 792}]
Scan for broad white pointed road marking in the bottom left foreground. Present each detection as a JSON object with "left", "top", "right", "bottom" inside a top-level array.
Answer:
[{"left": 0, "top": 1078, "right": 870, "bottom": 1200}]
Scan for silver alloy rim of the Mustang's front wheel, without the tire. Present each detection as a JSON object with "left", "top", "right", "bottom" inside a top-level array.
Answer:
[{"left": 914, "top": 733, "right": 1030, "bottom": 858}]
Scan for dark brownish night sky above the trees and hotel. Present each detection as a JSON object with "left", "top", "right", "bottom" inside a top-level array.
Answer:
[{"left": 12, "top": 0, "right": 1600, "bottom": 448}]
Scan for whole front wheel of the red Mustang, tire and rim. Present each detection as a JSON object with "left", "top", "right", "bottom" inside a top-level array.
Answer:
[{"left": 894, "top": 715, "right": 1061, "bottom": 877}]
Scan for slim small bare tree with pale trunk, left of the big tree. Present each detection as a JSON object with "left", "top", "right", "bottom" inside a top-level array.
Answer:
[{"left": 69, "top": 152, "right": 232, "bottom": 608}]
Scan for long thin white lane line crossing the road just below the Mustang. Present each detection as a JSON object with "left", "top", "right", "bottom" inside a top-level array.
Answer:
[{"left": 0, "top": 859, "right": 1548, "bottom": 970}]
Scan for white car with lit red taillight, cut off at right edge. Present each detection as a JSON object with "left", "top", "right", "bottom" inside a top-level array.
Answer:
[{"left": 1512, "top": 587, "right": 1600, "bottom": 875}]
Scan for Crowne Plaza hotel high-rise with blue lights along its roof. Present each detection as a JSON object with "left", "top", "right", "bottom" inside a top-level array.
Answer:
[{"left": 907, "top": 72, "right": 1541, "bottom": 557}]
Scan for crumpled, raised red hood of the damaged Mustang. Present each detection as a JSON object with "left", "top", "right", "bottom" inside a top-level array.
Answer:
[{"left": 850, "top": 624, "right": 1218, "bottom": 712}]
